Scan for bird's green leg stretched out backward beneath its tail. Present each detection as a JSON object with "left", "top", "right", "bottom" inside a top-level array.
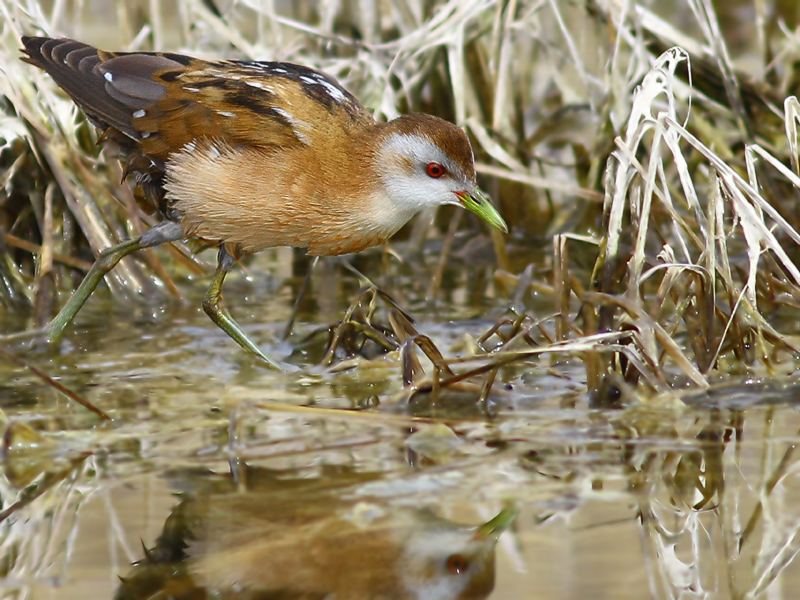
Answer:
[{"left": 45, "top": 221, "right": 181, "bottom": 343}]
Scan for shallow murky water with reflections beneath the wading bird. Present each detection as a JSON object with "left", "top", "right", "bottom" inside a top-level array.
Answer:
[{"left": 0, "top": 255, "right": 800, "bottom": 599}]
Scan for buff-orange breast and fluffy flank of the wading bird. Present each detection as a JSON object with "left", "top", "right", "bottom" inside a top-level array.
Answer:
[{"left": 165, "top": 144, "right": 410, "bottom": 256}]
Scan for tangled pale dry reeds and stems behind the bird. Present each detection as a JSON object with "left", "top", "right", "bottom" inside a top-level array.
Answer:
[{"left": 0, "top": 0, "right": 800, "bottom": 402}]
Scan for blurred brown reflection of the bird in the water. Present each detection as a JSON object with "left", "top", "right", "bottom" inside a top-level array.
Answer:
[{"left": 115, "top": 469, "right": 516, "bottom": 600}]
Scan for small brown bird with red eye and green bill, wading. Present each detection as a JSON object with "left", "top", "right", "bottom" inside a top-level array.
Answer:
[{"left": 22, "top": 36, "right": 508, "bottom": 368}]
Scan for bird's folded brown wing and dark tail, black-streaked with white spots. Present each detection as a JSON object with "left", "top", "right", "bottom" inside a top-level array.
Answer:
[{"left": 22, "top": 37, "right": 362, "bottom": 214}]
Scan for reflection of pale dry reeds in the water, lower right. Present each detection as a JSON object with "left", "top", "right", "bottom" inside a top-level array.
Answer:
[{"left": 625, "top": 398, "right": 800, "bottom": 599}]
